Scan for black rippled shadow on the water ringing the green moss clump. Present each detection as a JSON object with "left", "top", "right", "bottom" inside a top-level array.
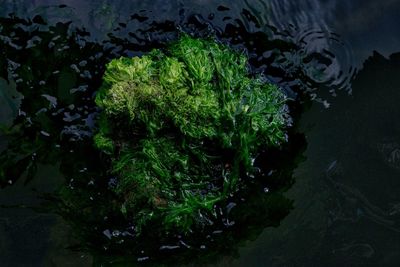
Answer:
[{"left": 0, "top": 3, "right": 353, "bottom": 266}]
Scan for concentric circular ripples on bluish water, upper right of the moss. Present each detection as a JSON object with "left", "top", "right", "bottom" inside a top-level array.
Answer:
[{"left": 243, "top": 0, "right": 356, "bottom": 102}]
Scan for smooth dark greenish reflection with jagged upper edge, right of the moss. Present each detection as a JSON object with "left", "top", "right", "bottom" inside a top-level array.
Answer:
[{"left": 226, "top": 50, "right": 400, "bottom": 266}]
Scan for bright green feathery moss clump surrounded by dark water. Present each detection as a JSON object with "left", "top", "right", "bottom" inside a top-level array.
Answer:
[{"left": 94, "top": 35, "right": 288, "bottom": 232}]
